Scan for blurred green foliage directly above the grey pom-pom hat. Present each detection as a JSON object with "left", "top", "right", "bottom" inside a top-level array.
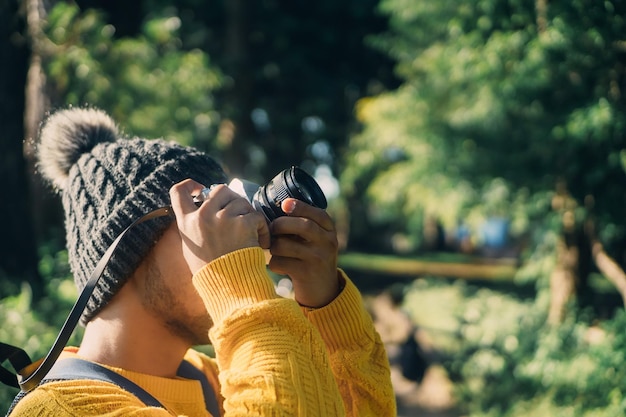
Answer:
[{"left": 43, "top": 2, "right": 222, "bottom": 147}]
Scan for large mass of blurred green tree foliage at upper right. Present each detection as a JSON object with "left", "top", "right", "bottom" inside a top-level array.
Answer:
[{"left": 341, "top": 0, "right": 626, "bottom": 255}]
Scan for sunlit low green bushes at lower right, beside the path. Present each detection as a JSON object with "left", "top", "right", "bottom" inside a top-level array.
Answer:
[{"left": 404, "top": 279, "right": 626, "bottom": 417}]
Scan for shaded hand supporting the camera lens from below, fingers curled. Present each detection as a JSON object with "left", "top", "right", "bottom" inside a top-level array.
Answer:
[{"left": 269, "top": 198, "right": 339, "bottom": 307}]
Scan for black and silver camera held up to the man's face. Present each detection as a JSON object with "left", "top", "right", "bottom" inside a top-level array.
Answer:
[{"left": 194, "top": 166, "right": 328, "bottom": 223}]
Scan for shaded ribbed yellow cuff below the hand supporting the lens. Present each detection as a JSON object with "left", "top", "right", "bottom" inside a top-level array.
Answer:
[{"left": 302, "top": 270, "right": 372, "bottom": 352}]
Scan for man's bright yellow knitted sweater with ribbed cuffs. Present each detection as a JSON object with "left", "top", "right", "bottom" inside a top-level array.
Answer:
[{"left": 11, "top": 248, "right": 396, "bottom": 417}]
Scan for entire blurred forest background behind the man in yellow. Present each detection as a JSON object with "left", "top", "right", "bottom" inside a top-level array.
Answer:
[{"left": 0, "top": 0, "right": 626, "bottom": 417}]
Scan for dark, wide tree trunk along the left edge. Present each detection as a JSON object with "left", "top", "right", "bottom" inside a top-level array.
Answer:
[{"left": 0, "top": 0, "right": 44, "bottom": 299}]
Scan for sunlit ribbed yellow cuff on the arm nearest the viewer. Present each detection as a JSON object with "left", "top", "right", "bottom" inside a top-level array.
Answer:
[{"left": 193, "top": 247, "right": 277, "bottom": 323}]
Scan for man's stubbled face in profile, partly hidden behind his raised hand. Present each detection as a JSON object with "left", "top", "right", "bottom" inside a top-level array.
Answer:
[{"left": 142, "top": 222, "right": 213, "bottom": 345}]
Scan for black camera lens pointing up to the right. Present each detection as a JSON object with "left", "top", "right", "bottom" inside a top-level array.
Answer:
[{"left": 252, "top": 167, "right": 327, "bottom": 222}]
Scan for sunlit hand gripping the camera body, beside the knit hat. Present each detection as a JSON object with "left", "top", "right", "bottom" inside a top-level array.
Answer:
[{"left": 170, "top": 180, "right": 270, "bottom": 273}]
